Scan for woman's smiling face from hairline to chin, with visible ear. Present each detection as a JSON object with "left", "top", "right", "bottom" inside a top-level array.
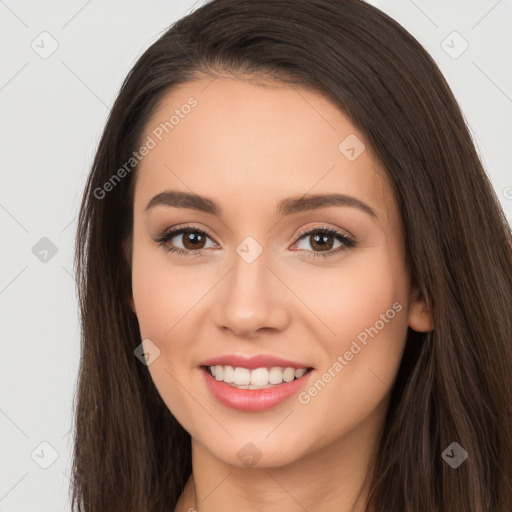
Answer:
[{"left": 132, "top": 78, "right": 431, "bottom": 466}]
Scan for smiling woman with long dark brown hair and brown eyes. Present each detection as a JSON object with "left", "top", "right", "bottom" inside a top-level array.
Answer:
[{"left": 72, "top": 0, "right": 512, "bottom": 512}]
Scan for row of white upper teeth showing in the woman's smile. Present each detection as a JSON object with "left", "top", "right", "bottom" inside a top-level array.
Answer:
[{"left": 209, "top": 365, "right": 307, "bottom": 386}]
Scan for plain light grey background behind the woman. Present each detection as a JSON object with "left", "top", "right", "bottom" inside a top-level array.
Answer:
[{"left": 0, "top": 0, "right": 512, "bottom": 512}]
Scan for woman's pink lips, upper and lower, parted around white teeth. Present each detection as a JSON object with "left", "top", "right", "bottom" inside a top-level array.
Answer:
[{"left": 200, "top": 355, "right": 313, "bottom": 412}]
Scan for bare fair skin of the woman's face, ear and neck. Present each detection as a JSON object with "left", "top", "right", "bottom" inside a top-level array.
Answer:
[{"left": 127, "top": 77, "right": 433, "bottom": 512}]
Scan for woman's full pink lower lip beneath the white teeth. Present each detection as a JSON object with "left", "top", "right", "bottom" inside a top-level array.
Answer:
[{"left": 201, "top": 366, "right": 313, "bottom": 412}]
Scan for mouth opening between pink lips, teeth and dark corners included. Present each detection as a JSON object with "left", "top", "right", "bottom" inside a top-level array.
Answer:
[{"left": 201, "top": 365, "right": 313, "bottom": 389}]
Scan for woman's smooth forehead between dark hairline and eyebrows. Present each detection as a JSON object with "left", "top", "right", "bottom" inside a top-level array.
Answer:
[{"left": 135, "top": 77, "right": 392, "bottom": 226}]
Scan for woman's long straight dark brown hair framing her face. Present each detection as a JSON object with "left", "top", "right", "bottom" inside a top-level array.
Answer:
[{"left": 71, "top": 0, "right": 512, "bottom": 512}]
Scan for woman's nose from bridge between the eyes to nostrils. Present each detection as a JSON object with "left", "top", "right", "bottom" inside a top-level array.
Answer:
[{"left": 215, "top": 237, "right": 287, "bottom": 336}]
